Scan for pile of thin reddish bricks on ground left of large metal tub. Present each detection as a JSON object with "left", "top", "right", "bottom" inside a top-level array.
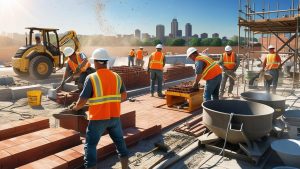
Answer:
[{"left": 174, "top": 116, "right": 207, "bottom": 137}]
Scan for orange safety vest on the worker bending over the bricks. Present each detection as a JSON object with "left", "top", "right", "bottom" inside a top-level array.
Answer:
[{"left": 195, "top": 56, "right": 222, "bottom": 80}]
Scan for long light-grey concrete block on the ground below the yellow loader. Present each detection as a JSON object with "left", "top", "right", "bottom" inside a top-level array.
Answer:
[{"left": 10, "top": 84, "right": 42, "bottom": 100}]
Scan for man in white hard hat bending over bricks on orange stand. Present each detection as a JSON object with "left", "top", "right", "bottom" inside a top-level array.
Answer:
[{"left": 186, "top": 47, "right": 222, "bottom": 101}]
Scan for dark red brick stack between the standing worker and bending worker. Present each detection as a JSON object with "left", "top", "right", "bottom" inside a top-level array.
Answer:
[{"left": 164, "top": 65, "right": 195, "bottom": 82}]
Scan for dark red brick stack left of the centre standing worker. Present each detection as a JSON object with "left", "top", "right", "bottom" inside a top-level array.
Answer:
[{"left": 111, "top": 66, "right": 150, "bottom": 89}]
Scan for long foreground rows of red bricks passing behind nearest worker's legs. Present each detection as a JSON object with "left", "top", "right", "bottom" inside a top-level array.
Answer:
[{"left": 0, "top": 112, "right": 161, "bottom": 169}]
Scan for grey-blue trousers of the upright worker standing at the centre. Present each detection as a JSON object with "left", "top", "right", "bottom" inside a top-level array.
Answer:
[{"left": 150, "top": 69, "right": 163, "bottom": 95}]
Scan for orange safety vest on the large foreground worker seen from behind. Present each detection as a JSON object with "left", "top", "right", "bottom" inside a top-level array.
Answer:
[{"left": 88, "top": 69, "right": 122, "bottom": 120}]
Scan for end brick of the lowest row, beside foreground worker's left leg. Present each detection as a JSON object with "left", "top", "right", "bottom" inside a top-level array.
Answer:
[{"left": 55, "top": 149, "right": 84, "bottom": 169}]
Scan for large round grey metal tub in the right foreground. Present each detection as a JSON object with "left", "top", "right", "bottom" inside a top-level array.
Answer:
[{"left": 202, "top": 100, "right": 274, "bottom": 144}]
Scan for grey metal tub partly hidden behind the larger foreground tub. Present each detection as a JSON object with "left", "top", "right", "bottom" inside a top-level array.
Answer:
[{"left": 241, "top": 92, "right": 285, "bottom": 119}]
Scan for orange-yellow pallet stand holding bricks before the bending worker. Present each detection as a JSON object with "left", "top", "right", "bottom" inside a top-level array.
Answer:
[{"left": 165, "top": 89, "right": 204, "bottom": 112}]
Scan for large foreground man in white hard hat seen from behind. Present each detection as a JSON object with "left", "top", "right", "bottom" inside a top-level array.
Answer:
[{"left": 72, "top": 48, "right": 128, "bottom": 169}]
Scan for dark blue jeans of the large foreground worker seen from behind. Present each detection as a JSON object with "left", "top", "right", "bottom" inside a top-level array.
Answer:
[{"left": 84, "top": 118, "right": 128, "bottom": 168}]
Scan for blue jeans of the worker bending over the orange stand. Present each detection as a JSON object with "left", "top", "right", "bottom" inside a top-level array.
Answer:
[{"left": 204, "top": 74, "right": 222, "bottom": 101}]
